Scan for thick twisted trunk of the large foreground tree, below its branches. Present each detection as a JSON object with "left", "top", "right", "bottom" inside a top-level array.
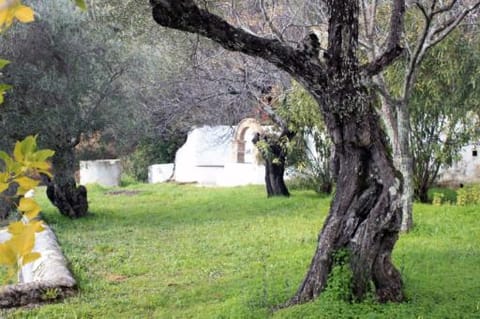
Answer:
[{"left": 290, "top": 92, "right": 403, "bottom": 303}]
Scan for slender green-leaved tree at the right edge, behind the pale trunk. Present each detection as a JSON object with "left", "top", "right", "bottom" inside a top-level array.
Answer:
[{"left": 409, "top": 30, "right": 480, "bottom": 202}]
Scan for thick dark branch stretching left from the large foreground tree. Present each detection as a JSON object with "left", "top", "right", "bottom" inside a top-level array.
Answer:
[{"left": 150, "top": 0, "right": 326, "bottom": 86}]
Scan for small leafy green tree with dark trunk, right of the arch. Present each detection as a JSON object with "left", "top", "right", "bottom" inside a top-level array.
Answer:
[{"left": 254, "top": 82, "right": 333, "bottom": 197}]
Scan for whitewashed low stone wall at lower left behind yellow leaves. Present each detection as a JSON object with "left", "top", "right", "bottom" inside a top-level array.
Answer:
[{"left": 0, "top": 226, "right": 76, "bottom": 308}]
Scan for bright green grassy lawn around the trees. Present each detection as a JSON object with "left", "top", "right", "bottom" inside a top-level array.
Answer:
[{"left": 0, "top": 185, "right": 480, "bottom": 319}]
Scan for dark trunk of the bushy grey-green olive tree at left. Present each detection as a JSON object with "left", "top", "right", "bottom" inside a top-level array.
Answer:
[{"left": 47, "top": 147, "right": 88, "bottom": 218}]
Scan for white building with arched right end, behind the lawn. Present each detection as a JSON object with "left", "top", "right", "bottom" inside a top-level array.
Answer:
[{"left": 173, "top": 118, "right": 265, "bottom": 186}]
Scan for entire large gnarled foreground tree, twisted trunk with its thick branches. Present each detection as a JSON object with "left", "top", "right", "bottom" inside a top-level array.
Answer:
[{"left": 151, "top": 0, "right": 404, "bottom": 305}]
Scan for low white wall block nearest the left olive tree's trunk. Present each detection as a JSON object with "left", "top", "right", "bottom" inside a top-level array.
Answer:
[{"left": 80, "top": 159, "right": 122, "bottom": 187}]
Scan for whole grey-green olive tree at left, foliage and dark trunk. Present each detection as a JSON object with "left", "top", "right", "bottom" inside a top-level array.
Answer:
[{"left": 0, "top": 1, "right": 146, "bottom": 218}]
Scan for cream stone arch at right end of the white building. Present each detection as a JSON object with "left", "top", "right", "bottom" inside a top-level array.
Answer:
[{"left": 233, "top": 118, "right": 263, "bottom": 163}]
